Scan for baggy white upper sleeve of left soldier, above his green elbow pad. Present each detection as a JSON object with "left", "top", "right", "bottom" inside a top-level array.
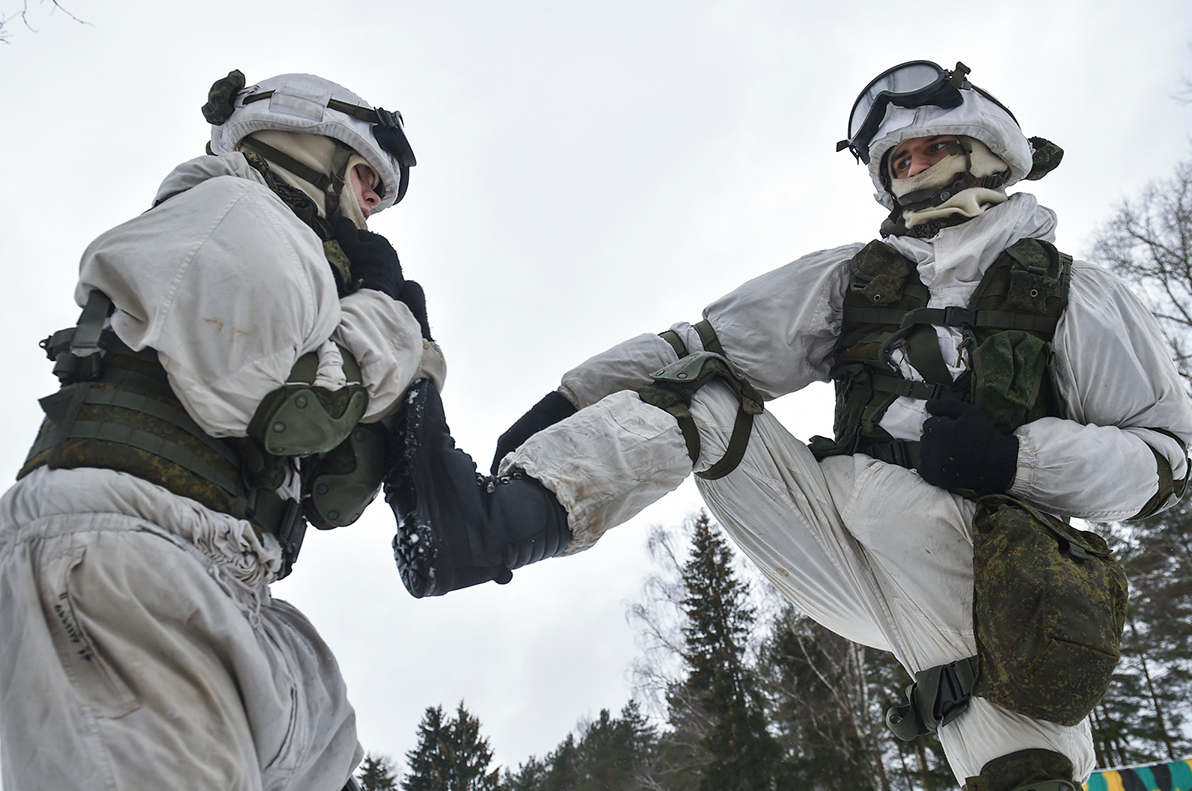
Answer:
[{"left": 75, "top": 176, "right": 340, "bottom": 436}]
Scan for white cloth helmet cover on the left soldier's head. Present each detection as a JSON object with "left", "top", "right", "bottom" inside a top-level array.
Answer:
[{"left": 211, "top": 74, "right": 414, "bottom": 214}]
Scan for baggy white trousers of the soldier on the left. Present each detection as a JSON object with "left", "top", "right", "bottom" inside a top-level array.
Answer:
[{"left": 0, "top": 471, "right": 361, "bottom": 791}]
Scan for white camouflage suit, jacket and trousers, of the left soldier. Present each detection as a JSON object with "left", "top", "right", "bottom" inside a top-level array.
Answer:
[{"left": 0, "top": 154, "right": 441, "bottom": 791}]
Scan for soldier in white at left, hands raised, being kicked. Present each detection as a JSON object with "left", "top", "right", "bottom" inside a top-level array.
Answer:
[{"left": 0, "top": 71, "right": 445, "bottom": 791}]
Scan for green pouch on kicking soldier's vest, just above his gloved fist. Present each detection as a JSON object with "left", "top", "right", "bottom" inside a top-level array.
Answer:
[{"left": 973, "top": 330, "right": 1058, "bottom": 434}]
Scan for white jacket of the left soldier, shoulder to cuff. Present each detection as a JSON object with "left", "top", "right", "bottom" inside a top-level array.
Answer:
[{"left": 75, "top": 154, "right": 437, "bottom": 436}]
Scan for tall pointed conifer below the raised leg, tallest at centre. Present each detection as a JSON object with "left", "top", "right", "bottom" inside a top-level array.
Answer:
[{"left": 670, "top": 512, "right": 778, "bottom": 791}]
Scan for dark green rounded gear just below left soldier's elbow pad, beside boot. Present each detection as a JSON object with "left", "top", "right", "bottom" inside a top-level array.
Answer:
[{"left": 302, "top": 423, "right": 389, "bottom": 530}]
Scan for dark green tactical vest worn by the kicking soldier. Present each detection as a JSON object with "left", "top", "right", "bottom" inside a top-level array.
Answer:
[{"left": 811, "top": 239, "right": 1072, "bottom": 467}]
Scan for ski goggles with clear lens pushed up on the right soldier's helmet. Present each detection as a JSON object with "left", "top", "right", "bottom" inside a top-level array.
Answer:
[{"left": 836, "top": 61, "right": 967, "bottom": 164}]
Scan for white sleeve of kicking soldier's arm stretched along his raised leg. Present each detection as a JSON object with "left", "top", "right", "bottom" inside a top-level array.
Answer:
[{"left": 559, "top": 244, "right": 862, "bottom": 409}]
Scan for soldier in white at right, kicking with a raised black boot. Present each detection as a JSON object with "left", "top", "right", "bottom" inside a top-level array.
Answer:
[{"left": 387, "top": 61, "right": 1192, "bottom": 791}]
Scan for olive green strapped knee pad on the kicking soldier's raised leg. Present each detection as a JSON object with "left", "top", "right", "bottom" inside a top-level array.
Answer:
[{"left": 638, "top": 351, "right": 764, "bottom": 480}]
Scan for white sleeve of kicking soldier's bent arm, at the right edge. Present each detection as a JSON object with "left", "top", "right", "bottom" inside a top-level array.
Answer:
[{"left": 1010, "top": 262, "right": 1192, "bottom": 519}]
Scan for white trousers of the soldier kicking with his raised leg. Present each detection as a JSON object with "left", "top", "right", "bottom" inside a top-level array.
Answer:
[{"left": 504, "top": 382, "right": 1095, "bottom": 783}]
